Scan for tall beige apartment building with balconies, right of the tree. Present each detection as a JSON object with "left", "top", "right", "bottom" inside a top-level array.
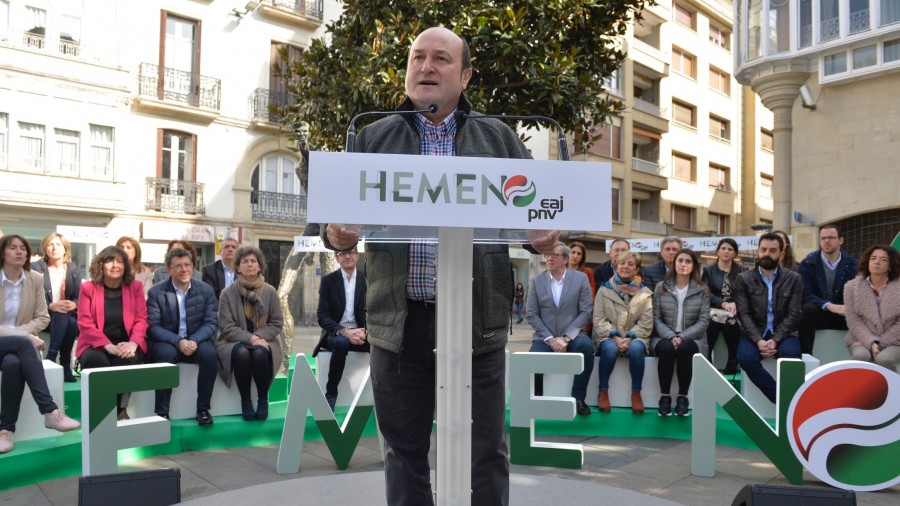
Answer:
[{"left": 569, "top": 0, "right": 774, "bottom": 262}]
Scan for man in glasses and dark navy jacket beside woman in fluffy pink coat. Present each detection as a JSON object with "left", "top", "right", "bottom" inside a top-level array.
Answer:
[{"left": 798, "top": 225, "right": 857, "bottom": 355}]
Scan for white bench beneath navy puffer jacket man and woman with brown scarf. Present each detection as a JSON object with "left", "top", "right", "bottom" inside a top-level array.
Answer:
[{"left": 128, "top": 363, "right": 257, "bottom": 420}]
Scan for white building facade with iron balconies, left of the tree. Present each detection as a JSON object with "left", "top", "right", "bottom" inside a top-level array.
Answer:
[{"left": 0, "top": 0, "right": 339, "bottom": 285}]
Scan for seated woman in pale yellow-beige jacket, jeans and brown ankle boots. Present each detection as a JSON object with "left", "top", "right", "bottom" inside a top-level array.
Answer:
[{"left": 594, "top": 251, "right": 653, "bottom": 413}]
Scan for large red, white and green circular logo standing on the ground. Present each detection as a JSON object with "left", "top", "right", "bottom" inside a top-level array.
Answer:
[{"left": 787, "top": 361, "right": 900, "bottom": 492}]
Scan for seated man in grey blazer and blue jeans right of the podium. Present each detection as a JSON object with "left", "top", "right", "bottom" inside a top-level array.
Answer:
[{"left": 526, "top": 243, "right": 594, "bottom": 415}]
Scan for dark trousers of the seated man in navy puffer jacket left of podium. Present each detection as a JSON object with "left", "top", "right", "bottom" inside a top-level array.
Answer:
[{"left": 150, "top": 341, "right": 219, "bottom": 415}]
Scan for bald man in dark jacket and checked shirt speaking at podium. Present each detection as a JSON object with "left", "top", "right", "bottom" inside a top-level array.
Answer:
[{"left": 322, "top": 28, "right": 559, "bottom": 506}]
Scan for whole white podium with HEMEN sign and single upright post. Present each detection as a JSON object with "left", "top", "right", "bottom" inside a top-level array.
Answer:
[{"left": 307, "top": 152, "right": 611, "bottom": 505}]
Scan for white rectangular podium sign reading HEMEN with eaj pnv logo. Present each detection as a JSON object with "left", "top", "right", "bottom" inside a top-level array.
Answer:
[{"left": 307, "top": 152, "right": 612, "bottom": 231}]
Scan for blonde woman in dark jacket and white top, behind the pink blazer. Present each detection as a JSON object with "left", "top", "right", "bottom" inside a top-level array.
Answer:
[{"left": 31, "top": 232, "right": 81, "bottom": 383}]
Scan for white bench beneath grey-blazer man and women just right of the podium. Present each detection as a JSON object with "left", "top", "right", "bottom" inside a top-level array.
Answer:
[{"left": 544, "top": 357, "right": 694, "bottom": 409}]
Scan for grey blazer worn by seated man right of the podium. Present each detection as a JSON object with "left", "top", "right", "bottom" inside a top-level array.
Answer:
[{"left": 526, "top": 269, "right": 593, "bottom": 341}]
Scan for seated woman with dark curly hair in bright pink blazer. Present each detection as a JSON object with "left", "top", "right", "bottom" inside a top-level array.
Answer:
[{"left": 75, "top": 246, "right": 147, "bottom": 420}]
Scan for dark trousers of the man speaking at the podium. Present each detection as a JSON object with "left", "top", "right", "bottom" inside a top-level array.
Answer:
[{"left": 370, "top": 301, "right": 509, "bottom": 506}]
